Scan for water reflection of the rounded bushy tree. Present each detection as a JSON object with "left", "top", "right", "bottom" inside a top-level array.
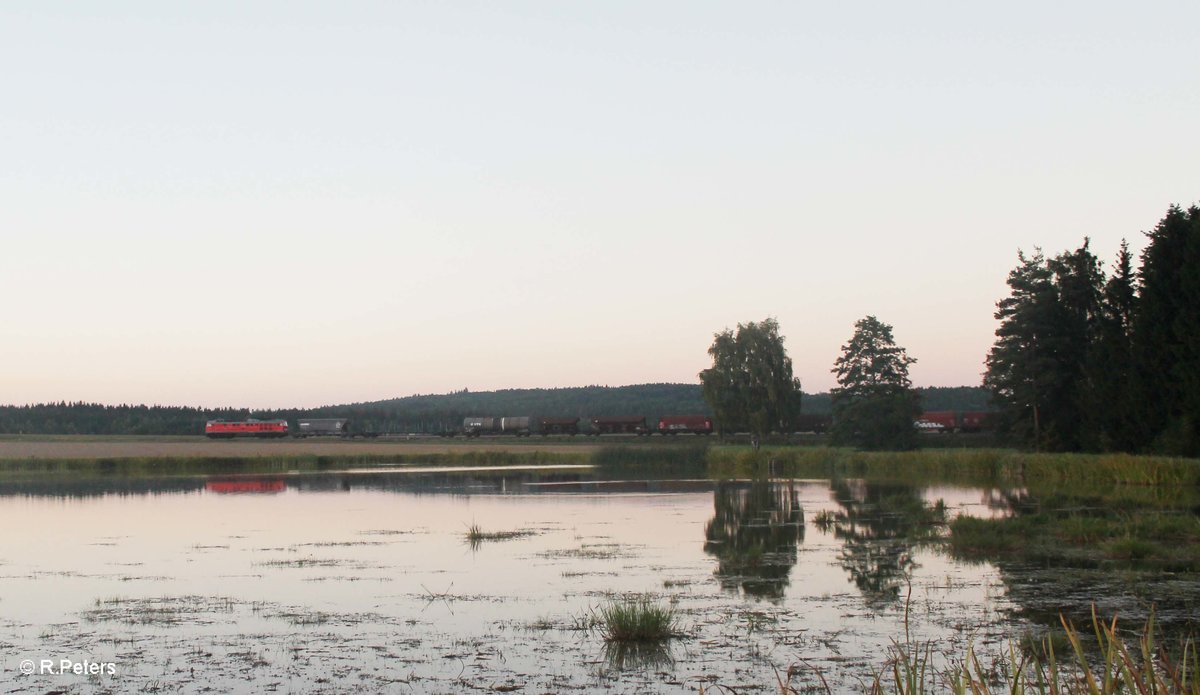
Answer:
[{"left": 704, "top": 481, "right": 804, "bottom": 599}]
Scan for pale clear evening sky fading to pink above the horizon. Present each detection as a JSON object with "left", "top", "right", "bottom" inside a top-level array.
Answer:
[{"left": 0, "top": 0, "right": 1200, "bottom": 408}]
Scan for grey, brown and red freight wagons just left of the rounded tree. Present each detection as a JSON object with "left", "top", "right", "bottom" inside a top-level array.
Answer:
[{"left": 462, "top": 415, "right": 713, "bottom": 437}]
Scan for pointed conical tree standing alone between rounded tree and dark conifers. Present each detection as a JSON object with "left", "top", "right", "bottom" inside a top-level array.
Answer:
[{"left": 833, "top": 316, "right": 920, "bottom": 449}]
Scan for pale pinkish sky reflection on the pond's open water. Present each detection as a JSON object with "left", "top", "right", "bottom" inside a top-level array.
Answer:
[{"left": 0, "top": 473, "right": 1022, "bottom": 690}]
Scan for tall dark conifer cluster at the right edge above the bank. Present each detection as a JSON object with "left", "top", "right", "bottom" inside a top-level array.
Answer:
[{"left": 984, "top": 206, "right": 1200, "bottom": 456}]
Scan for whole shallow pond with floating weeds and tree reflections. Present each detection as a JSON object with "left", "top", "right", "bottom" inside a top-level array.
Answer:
[{"left": 0, "top": 448, "right": 1200, "bottom": 693}]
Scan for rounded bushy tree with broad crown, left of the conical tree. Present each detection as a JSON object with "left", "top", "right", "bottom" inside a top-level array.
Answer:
[{"left": 700, "top": 318, "right": 800, "bottom": 435}]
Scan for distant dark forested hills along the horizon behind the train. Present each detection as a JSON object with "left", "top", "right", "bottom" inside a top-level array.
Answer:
[{"left": 0, "top": 384, "right": 989, "bottom": 435}]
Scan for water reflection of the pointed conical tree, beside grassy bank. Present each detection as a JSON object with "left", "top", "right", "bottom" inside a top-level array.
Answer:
[{"left": 817, "top": 480, "right": 946, "bottom": 605}]
